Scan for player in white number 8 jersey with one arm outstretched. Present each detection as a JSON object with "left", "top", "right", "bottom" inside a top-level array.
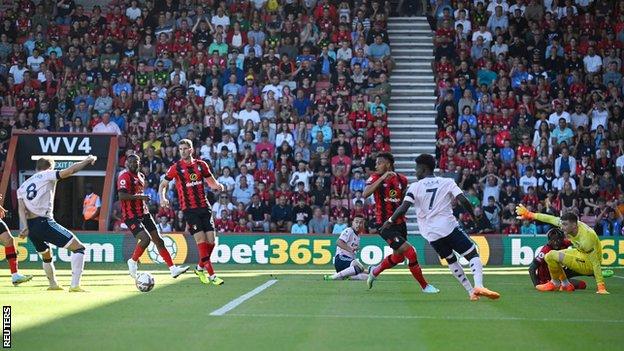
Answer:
[{"left": 17, "top": 155, "right": 97, "bottom": 292}]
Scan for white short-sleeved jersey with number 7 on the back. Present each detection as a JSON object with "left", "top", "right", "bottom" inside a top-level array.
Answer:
[{"left": 403, "top": 177, "right": 463, "bottom": 242}]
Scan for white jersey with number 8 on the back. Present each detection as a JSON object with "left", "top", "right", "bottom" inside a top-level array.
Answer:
[{"left": 17, "top": 170, "right": 60, "bottom": 218}]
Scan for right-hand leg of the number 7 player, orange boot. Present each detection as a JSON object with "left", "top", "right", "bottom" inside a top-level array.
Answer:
[{"left": 447, "top": 227, "right": 500, "bottom": 299}]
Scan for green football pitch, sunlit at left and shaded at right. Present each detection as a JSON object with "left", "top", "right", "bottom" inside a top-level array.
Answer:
[{"left": 0, "top": 264, "right": 624, "bottom": 351}]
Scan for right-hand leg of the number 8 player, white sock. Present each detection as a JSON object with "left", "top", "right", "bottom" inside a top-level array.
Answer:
[{"left": 43, "top": 219, "right": 85, "bottom": 292}]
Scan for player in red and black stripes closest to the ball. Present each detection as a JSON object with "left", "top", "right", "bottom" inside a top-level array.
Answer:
[{"left": 117, "top": 154, "right": 189, "bottom": 278}]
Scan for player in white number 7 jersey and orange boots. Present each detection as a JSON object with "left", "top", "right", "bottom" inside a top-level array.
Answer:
[{"left": 382, "top": 154, "right": 500, "bottom": 301}]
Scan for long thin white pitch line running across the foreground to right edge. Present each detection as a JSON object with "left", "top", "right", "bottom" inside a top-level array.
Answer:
[{"left": 228, "top": 313, "right": 624, "bottom": 324}]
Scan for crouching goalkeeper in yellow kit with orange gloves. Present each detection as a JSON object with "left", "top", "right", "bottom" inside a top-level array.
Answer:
[{"left": 516, "top": 204, "right": 609, "bottom": 294}]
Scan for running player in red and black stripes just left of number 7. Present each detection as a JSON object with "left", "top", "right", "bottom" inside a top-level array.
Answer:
[{"left": 362, "top": 152, "right": 440, "bottom": 294}]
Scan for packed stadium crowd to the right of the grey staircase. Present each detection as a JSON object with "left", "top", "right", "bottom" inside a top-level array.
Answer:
[{"left": 428, "top": 0, "right": 624, "bottom": 236}]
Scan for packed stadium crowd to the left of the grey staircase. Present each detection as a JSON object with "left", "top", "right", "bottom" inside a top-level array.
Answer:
[{"left": 0, "top": 0, "right": 400, "bottom": 233}]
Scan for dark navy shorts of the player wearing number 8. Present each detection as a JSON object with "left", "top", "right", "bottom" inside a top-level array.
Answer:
[{"left": 27, "top": 217, "right": 74, "bottom": 252}]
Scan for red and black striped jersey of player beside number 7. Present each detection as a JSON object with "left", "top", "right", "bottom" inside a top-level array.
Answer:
[{"left": 366, "top": 173, "right": 407, "bottom": 225}]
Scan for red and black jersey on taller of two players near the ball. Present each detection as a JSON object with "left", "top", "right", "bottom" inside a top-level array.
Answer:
[{"left": 165, "top": 159, "right": 212, "bottom": 211}]
